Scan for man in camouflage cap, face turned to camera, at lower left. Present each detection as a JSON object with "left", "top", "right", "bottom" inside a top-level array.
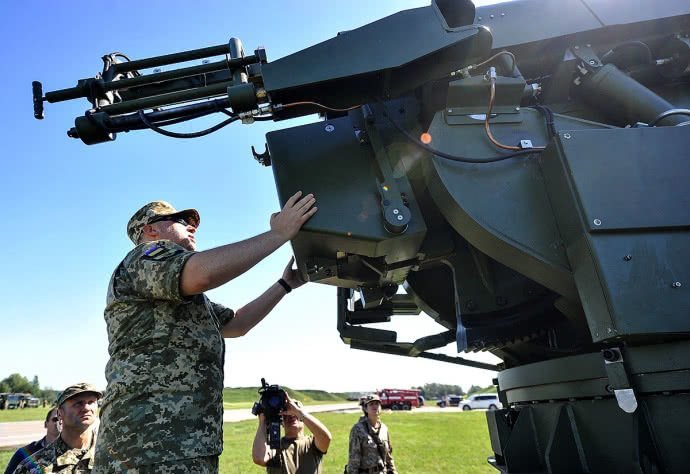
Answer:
[{"left": 14, "top": 383, "right": 102, "bottom": 474}]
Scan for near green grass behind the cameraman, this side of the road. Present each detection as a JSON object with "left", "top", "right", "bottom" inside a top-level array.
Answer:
[{"left": 0, "top": 410, "right": 496, "bottom": 474}]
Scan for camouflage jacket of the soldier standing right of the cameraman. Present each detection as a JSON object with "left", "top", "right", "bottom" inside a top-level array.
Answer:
[{"left": 347, "top": 416, "right": 398, "bottom": 474}]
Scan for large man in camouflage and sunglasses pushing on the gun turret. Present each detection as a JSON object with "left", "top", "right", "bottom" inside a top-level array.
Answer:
[{"left": 94, "top": 192, "right": 316, "bottom": 473}]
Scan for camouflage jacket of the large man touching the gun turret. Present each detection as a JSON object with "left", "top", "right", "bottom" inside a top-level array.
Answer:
[{"left": 95, "top": 240, "right": 233, "bottom": 472}]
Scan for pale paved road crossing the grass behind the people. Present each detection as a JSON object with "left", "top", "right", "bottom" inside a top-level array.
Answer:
[{"left": 0, "top": 402, "right": 460, "bottom": 448}]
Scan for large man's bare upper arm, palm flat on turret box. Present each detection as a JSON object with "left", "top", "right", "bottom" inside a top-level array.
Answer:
[{"left": 180, "top": 191, "right": 317, "bottom": 296}]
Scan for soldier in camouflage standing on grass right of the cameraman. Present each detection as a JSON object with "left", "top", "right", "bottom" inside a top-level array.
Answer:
[{"left": 347, "top": 394, "right": 398, "bottom": 474}]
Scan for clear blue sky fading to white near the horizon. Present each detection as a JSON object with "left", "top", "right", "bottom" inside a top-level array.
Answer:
[{"left": 0, "top": 0, "right": 506, "bottom": 391}]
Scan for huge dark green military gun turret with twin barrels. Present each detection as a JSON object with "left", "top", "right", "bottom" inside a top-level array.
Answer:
[{"left": 29, "top": 0, "right": 690, "bottom": 473}]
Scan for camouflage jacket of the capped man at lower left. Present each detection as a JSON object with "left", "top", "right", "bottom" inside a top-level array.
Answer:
[{"left": 14, "top": 433, "right": 96, "bottom": 474}]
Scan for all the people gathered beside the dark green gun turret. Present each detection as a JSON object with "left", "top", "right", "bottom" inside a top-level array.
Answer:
[{"left": 6, "top": 198, "right": 396, "bottom": 474}]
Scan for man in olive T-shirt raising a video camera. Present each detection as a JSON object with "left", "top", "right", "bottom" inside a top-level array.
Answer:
[{"left": 252, "top": 394, "right": 331, "bottom": 474}]
